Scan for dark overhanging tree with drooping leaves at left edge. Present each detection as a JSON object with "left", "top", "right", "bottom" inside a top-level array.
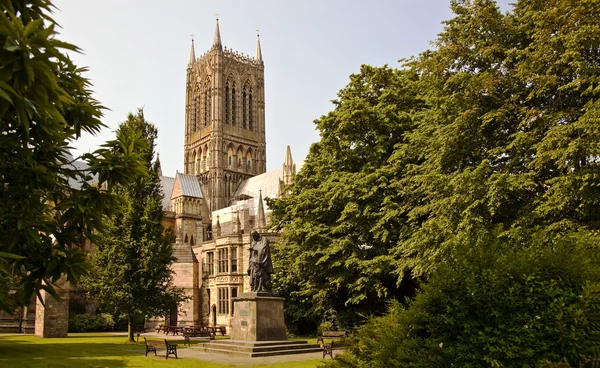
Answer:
[{"left": 0, "top": 0, "right": 144, "bottom": 311}]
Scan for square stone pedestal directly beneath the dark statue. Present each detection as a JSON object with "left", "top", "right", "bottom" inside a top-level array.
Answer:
[{"left": 231, "top": 292, "right": 286, "bottom": 341}]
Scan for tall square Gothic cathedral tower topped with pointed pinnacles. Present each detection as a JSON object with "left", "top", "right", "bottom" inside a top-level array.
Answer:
[{"left": 184, "top": 19, "right": 267, "bottom": 212}]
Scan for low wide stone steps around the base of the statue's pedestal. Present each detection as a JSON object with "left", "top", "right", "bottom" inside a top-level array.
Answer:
[{"left": 194, "top": 340, "right": 323, "bottom": 357}]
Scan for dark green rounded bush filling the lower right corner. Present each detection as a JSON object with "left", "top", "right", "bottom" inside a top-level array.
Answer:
[{"left": 331, "top": 237, "right": 600, "bottom": 368}]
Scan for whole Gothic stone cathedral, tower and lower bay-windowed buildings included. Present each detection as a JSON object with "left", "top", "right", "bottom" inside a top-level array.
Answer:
[{"left": 148, "top": 20, "right": 302, "bottom": 327}]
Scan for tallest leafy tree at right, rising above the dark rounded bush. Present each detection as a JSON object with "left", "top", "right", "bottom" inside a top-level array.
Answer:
[{"left": 384, "top": 0, "right": 600, "bottom": 277}]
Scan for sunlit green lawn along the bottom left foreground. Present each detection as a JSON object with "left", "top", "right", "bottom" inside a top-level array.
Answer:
[{"left": 0, "top": 334, "right": 320, "bottom": 368}]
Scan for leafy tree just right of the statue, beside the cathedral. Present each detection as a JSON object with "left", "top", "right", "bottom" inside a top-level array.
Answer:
[{"left": 269, "top": 65, "right": 422, "bottom": 332}]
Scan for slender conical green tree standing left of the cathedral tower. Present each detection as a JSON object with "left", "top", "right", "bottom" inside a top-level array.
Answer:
[{"left": 84, "top": 109, "right": 184, "bottom": 342}]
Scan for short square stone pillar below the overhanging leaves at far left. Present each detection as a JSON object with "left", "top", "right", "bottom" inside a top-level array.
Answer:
[{"left": 35, "top": 276, "right": 69, "bottom": 337}]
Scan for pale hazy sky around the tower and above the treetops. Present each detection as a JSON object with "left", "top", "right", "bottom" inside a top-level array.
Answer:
[{"left": 54, "top": 0, "right": 510, "bottom": 176}]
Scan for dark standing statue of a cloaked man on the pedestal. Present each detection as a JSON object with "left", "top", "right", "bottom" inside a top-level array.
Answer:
[{"left": 248, "top": 230, "right": 273, "bottom": 292}]
